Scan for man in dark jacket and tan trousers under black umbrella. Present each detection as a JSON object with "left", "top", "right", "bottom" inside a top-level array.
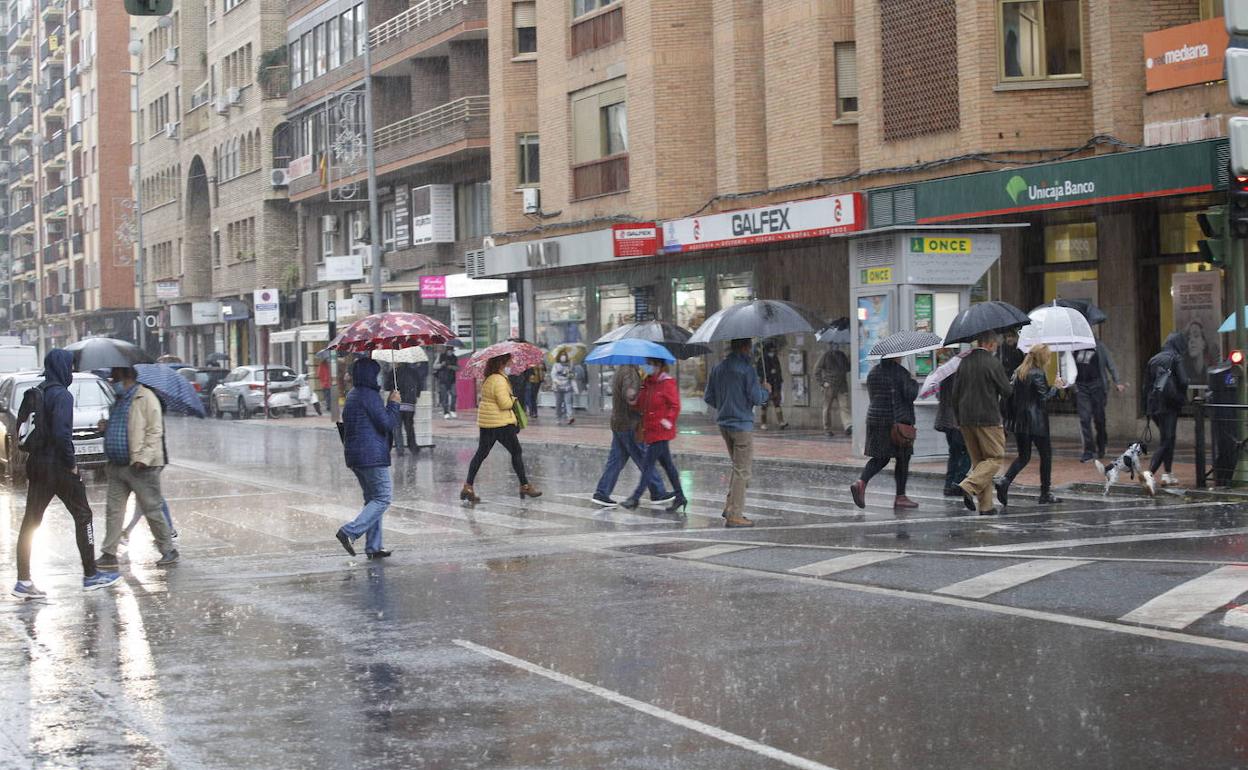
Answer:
[{"left": 953, "top": 332, "right": 1013, "bottom": 515}]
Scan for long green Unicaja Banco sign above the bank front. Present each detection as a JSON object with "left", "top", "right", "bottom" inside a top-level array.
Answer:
[{"left": 915, "top": 140, "right": 1226, "bottom": 225}]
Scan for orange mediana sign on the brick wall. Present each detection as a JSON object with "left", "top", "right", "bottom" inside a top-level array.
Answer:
[{"left": 1144, "top": 16, "right": 1231, "bottom": 94}]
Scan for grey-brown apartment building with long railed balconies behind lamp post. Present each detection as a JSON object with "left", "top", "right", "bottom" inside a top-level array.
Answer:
[{"left": 282, "top": 0, "right": 510, "bottom": 357}]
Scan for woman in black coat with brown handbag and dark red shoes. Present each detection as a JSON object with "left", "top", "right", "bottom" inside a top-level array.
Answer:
[{"left": 850, "top": 358, "right": 919, "bottom": 508}]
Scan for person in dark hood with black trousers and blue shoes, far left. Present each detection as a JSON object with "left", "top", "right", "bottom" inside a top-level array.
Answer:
[{"left": 12, "top": 348, "right": 121, "bottom": 599}]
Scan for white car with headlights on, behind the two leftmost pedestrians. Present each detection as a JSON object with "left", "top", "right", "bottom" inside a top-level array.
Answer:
[{"left": 0, "top": 372, "right": 114, "bottom": 480}]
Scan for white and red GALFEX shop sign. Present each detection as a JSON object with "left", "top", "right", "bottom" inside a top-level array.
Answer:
[{"left": 663, "top": 192, "right": 866, "bottom": 252}]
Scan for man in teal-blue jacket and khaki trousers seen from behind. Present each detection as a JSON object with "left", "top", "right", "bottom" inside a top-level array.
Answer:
[{"left": 703, "top": 339, "right": 771, "bottom": 528}]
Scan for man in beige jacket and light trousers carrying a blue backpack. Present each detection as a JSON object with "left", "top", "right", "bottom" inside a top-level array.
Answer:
[{"left": 100, "top": 367, "right": 178, "bottom": 569}]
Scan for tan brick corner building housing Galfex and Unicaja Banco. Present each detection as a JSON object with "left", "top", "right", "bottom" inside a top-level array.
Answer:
[{"left": 483, "top": 0, "right": 1248, "bottom": 432}]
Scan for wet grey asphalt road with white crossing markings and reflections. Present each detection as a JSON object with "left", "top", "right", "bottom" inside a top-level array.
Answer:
[{"left": 0, "top": 421, "right": 1248, "bottom": 770}]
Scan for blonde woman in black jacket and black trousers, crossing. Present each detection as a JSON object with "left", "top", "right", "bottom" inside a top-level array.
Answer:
[{"left": 996, "top": 344, "right": 1066, "bottom": 505}]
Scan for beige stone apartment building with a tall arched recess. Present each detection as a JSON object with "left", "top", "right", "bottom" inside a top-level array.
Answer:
[{"left": 131, "top": 0, "right": 302, "bottom": 366}]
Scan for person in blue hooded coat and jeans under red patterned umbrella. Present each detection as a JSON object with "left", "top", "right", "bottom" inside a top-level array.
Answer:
[{"left": 336, "top": 358, "right": 402, "bottom": 559}]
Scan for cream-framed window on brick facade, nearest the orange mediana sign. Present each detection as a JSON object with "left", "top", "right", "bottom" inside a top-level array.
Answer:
[{"left": 1001, "top": 0, "right": 1083, "bottom": 80}]
